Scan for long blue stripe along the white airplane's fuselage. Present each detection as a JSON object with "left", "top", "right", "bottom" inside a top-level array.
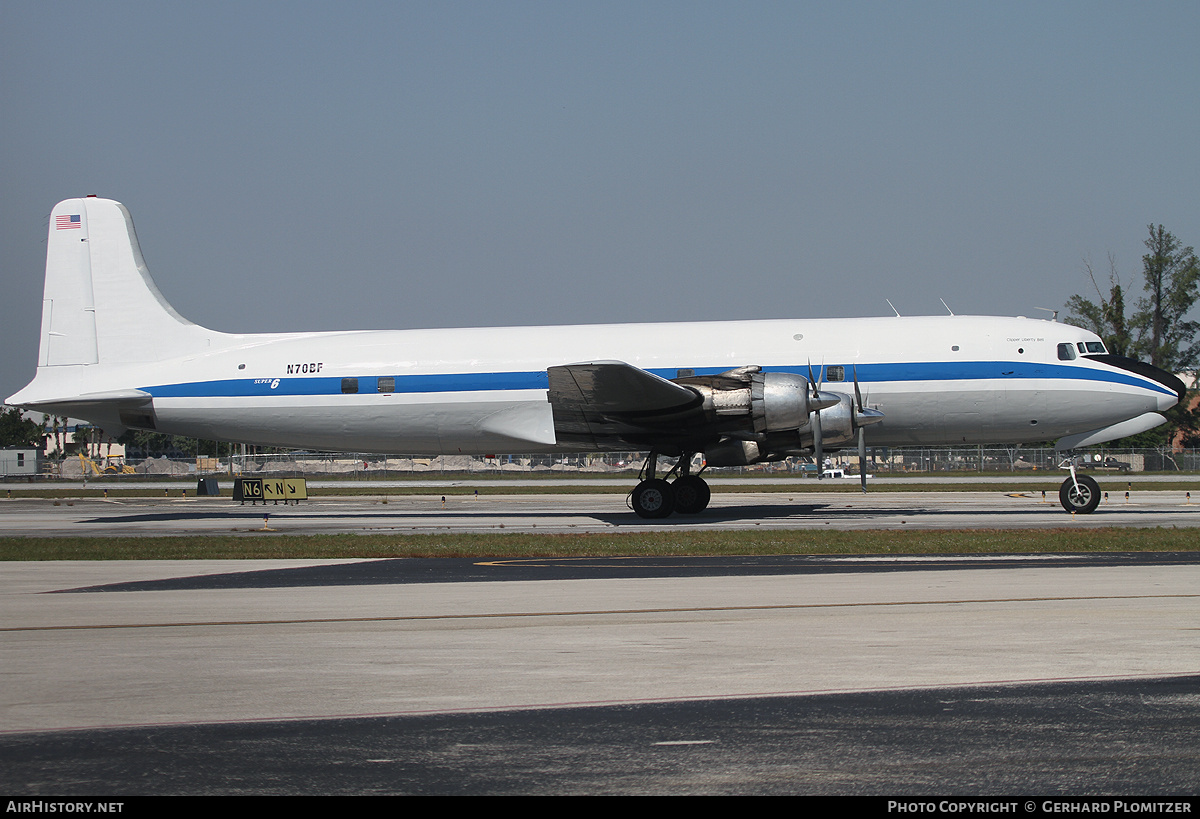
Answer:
[{"left": 140, "top": 361, "right": 1175, "bottom": 397}]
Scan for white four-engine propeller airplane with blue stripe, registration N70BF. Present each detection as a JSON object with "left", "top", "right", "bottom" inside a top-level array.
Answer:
[{"left": 8, "top": 197, "right": 1183, "bottom": 518}]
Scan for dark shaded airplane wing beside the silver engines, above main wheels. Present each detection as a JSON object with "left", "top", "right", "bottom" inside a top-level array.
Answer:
[{"left": 547, "top": 361, "right": 703, "bottom": 449}]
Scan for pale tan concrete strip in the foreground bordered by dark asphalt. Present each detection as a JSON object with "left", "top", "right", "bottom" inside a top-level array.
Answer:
[{"left": 0, "top": 561, "right": 1200, "bottom": 731}]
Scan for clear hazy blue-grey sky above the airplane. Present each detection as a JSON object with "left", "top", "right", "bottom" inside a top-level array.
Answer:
[{"left": 0, "top": 0, "right": 1200, "bottom": 395}]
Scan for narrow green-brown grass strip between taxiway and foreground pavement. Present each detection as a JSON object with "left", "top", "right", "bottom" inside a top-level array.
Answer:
[{"left": 0, "top": 528, "right": 1200, "bottom": 561}]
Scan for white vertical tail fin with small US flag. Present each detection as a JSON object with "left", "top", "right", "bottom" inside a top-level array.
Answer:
[{"left": 37, "top": 197, "right": 220, "bottom": 369}]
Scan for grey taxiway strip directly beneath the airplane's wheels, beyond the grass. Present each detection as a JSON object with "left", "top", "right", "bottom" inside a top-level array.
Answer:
[{"left": 0, "top": 489, "right": 1200, "bottom": 537}]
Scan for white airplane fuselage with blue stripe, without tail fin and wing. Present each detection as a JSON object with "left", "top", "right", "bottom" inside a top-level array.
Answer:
[{"left": 39, "top": 316, "right": 1177, "bottom": 455}]
